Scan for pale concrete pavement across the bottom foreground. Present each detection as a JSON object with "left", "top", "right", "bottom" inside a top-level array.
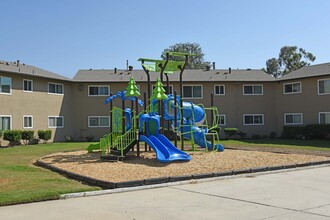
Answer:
[{"left": 0, "top": 166, "right": 330, "bottom": 220}]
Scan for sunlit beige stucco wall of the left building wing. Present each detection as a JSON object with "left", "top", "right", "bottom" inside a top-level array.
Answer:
[{"left": 0, "top": 73, "right": 73, "bottom": 141}]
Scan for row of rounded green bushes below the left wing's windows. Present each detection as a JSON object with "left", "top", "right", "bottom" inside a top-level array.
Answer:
[{"left": 3, "top": 130, "right": 52, "bottom": 145}]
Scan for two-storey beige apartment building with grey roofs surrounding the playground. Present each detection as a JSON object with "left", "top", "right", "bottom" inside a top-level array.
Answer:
[{"left": 0, "top": 61, "right": 330, "bottom": 144}]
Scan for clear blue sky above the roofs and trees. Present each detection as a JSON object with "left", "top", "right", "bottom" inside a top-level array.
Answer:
[{"left": 0, "top": 0, "right": 330, "bottom": 77}]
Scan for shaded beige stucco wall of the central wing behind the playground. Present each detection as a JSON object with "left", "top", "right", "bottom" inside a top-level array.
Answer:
[{"left": 69, "top": 82, "right": 277, "bottom": 139}]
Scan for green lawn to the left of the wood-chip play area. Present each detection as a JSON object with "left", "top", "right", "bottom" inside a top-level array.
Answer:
[{"left": 0, "top": 143, "right": 100, "bottom": 206}]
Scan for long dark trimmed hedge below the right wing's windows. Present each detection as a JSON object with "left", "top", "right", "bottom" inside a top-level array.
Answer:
[{"left": 282, "top": 124, "right": 330, "bottom": 139}]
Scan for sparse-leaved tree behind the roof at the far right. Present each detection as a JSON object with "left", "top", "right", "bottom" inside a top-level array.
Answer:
[{"left": 265, "top": 46, "right": 316, "bottom": 77}]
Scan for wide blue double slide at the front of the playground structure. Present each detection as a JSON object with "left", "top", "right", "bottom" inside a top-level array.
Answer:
[{"left": 140, "top": 134, "right": 191, "bottom": 163}]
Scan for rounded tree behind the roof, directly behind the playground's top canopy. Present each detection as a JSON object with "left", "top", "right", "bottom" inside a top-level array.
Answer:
[{"left": 161, "top": 42, "right": 210, "bottom": 69}]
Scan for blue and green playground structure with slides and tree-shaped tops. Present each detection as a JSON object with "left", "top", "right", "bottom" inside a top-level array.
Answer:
[{"left": 87, "top": 52, "right": 224, "bottom": 162}]
